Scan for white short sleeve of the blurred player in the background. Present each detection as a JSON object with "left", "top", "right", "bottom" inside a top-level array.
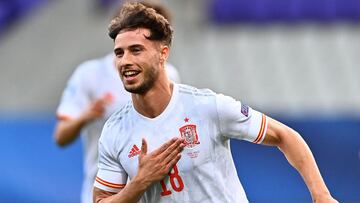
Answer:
[{"left": 57, "top": 64, "right": 90, "bottom": 119}]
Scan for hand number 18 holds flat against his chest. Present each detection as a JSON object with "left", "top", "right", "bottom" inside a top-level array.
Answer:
[{"left": 135, "top": 138, "right": 185, "bottom": 186}]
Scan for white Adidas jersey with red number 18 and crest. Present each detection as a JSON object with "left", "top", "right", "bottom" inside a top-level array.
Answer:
[{"left": 94, "top": 84, "right": 267, "bottom": 203}]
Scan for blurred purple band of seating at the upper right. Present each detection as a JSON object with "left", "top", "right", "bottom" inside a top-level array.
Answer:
[{"left": 210, "top": 0, "right": 360, "bottom": 23}]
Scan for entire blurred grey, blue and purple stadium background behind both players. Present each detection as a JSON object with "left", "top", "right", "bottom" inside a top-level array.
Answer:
[{"left": 0, "top": 0, "right": 360, "bottom": 203}]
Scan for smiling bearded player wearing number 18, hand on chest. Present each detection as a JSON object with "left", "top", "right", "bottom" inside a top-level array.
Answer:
[{"left": 94, "top": 3, "right": 336, "bottom": 203}]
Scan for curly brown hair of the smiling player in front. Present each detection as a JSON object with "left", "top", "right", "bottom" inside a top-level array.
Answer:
[{"left": 109, "top": 3, "right": 173, "bottom": 46}]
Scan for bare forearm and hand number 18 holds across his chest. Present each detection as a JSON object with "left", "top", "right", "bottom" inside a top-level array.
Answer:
[{"left": 93, "top": 138, "right": 184, "bottom": 203}]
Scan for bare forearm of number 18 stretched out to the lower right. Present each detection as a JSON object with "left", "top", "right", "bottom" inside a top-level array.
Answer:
[{"left": 278, "top": 129, "right": 330, "bottom": 200}]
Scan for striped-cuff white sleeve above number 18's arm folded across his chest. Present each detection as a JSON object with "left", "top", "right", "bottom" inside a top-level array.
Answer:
[{"left": 94, "top": 125, "right": 128, "bottom": 193}]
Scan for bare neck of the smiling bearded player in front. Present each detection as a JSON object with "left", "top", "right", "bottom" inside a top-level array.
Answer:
[{"left": 131, "top": 77, "right": 174, "bottom": 118}]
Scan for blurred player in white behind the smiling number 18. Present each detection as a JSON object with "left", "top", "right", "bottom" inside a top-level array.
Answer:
[{"left": 54, "top": 2, "right": 180, "bottom": 203}]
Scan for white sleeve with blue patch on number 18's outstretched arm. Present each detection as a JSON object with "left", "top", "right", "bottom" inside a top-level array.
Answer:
[{"left": 216, "top": 94, "right": 267, "bottom": 143}]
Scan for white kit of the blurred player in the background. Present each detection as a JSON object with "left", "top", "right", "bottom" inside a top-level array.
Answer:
[{"left": 57, "top": 54, "right": 179, "bottom": 203}]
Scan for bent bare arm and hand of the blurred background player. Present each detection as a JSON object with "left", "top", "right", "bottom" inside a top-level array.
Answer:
[{"left": 54, "top": 97, "right": 109, "bottom": 146}]
